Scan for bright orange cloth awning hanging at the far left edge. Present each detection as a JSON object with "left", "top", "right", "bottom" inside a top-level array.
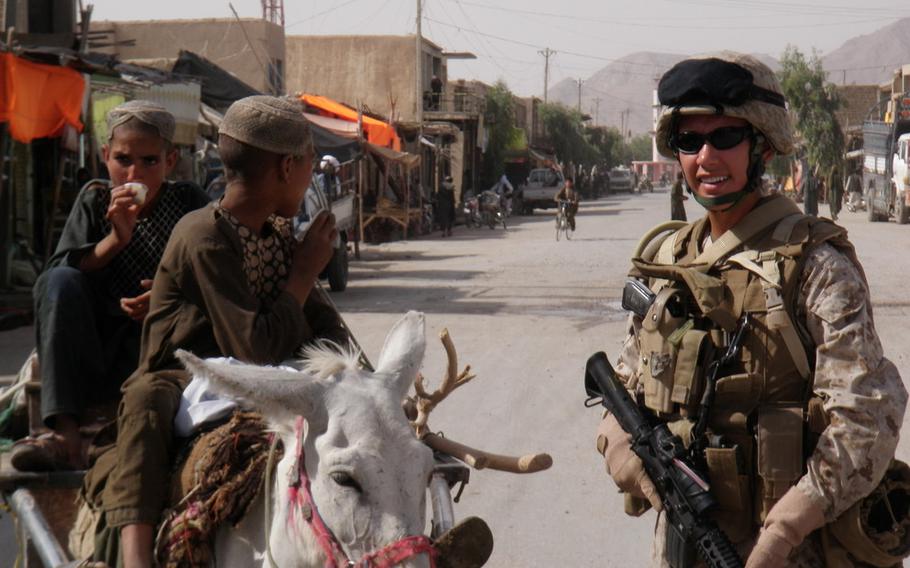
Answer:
[{"left": 0, "top": 53, "right": 85, "bottom": 144}]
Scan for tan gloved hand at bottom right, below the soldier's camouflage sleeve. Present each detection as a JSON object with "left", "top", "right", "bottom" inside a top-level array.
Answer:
[{"left": 746, "top": 486, "right": 825, "bottom": 568}]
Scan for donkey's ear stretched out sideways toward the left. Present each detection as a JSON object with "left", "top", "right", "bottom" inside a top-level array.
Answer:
[{"left": 176, "top": 349, "right": 325, "bottom": 422}]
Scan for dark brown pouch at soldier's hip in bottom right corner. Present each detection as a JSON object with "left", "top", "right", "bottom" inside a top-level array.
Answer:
[{"left": 822, "top": 459, "right": 910, "bottom": 568}]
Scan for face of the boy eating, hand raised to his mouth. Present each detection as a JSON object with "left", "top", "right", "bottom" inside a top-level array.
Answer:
[{"left": 102, "top": 128, "right": 177, "bottom": 203}]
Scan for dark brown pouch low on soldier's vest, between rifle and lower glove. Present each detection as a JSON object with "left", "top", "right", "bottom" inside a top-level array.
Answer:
[{"left": 705, "top": 447, "right": 753, "bottom": 543}]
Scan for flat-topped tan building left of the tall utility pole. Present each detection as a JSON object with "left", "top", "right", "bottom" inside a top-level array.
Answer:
[{"left": 285, "top": 36, "right": 446, "bottom": 122}]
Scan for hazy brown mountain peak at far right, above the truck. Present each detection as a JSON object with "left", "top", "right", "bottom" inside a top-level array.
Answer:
[{"left": 822, "top": 18, "right": 910, "bottom": 85}]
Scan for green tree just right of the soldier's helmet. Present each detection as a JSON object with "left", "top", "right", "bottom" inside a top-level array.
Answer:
[{"left": 778, "top": 45, "right": 844, "bottom": 171}]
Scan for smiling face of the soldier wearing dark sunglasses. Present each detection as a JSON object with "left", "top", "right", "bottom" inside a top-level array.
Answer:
[{"left": 679, "top": 115, "right": 749, "bottom": 209}]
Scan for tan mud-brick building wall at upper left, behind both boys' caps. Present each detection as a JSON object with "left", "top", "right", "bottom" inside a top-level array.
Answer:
[{"left": 91, "top": 18, "right": 286, "bottom": 94}]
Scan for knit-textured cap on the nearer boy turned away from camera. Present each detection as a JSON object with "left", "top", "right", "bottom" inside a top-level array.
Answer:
[{"left": 218, "top": 95, "right": 313, "bottom": 156}]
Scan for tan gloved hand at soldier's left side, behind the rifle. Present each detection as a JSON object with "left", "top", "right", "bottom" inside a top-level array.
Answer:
[{"left": 597, "top": 413, "right": 663, "bottom": 511}]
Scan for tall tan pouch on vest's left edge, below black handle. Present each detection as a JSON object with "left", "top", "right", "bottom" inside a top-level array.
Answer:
[{"left": 638, "top": 288, "right": 686, "bottom": 413}]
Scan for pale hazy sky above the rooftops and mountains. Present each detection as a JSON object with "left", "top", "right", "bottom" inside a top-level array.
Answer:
[{"left": 89, "top": 0, "right": 910, "bottom": 95}]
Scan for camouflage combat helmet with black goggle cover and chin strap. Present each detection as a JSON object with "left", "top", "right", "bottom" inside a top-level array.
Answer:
[{"left": 655, "top": 51, "right": 793, "bottom": 207}]
